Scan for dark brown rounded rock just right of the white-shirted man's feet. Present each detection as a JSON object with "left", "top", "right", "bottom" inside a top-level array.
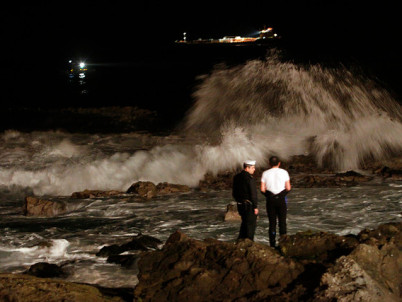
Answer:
[{"left": 279, "top": 231, "right": 359, "bottom": 263}]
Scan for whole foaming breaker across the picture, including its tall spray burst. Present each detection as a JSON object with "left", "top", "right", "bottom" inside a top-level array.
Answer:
[{"left": 0, "top": 56, "right": 402, "bottom": 195}]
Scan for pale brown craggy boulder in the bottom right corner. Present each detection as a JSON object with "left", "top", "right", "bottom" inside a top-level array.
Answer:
[{"left": 314, "top": 242, "right": 402, "bottom": 302}]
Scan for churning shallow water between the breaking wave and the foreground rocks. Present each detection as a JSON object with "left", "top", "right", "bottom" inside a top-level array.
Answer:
[{"left": 0, "top": 184, "right": 402, "bottom": 287}]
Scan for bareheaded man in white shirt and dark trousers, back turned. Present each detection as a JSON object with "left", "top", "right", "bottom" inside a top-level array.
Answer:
[{"left": 261, "top": 156, "right": 291, "bottom": 247}]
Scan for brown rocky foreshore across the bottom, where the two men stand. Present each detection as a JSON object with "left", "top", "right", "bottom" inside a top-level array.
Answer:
[{"left": 0, "top": 222, "right": 402, "bottom": 302}]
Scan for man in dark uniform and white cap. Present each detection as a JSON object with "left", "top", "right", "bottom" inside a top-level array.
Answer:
[{"left": 232, "top": 161, "right": 258, "bottom": 240}]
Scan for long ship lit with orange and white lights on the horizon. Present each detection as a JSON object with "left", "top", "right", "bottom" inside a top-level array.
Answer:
[{"left": 176, "top": 27, "right": 280, "bottom": 44}]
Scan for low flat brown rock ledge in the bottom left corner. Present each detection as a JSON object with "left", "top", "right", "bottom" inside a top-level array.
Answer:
[{"left": 0, "top": 274, "right": 124, "bottom": 302}]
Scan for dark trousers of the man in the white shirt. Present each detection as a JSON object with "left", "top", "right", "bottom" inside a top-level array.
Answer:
[{"left": 266, "top": 195, "right": 287, "bottom": 247}]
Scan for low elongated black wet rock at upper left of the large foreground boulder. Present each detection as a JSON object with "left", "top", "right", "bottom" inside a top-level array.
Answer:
[{"left": 96, "top": 234, "right": 162, "bottom": 257}]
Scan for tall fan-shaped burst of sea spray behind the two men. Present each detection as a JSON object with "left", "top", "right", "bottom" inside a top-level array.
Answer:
[{"left": 185, "top": 55, "right": 402, "bottom": 170}]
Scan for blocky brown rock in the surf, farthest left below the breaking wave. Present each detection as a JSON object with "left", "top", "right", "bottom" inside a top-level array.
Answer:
[{"left": 23, "top": 196, "right": 67, "bottom": 217}]
